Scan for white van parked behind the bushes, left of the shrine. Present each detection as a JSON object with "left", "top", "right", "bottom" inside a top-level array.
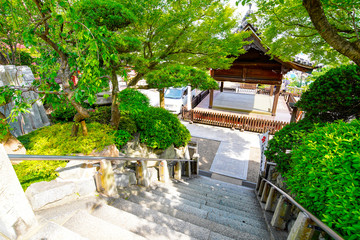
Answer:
[{"left": 165, "top": 87, "right": 196, "bottom": 114}]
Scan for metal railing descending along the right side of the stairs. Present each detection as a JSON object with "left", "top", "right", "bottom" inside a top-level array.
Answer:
[{"left": 256, "top": 162, "right": 344, "bottom": 240}]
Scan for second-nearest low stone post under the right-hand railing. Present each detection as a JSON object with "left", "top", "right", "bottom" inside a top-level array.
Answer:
[{"left": 271, "top": 196, "right": 291, "bottom": 230}]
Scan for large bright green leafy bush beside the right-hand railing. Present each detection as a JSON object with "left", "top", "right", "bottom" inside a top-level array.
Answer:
[{"left": 285, "top": 120, "right": 360, "bottom": 239}]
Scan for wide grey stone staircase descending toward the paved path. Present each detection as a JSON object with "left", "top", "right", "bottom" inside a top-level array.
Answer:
[{"left": 25, "top": 177, "right": 270, "bottom": 240}]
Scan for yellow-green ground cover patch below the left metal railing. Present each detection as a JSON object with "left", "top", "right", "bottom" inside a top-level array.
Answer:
[{"left": 13, "top": 161, "right": 66, "bottom": 191}]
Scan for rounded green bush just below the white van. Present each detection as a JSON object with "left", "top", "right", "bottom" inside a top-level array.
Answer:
[{"left": 135, "top": 107, "right": 191, "bottom": 149}]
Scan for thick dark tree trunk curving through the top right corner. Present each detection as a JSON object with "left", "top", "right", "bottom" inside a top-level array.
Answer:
[{"left": 303, "top": 0, "right": 360, "bottom": 66}]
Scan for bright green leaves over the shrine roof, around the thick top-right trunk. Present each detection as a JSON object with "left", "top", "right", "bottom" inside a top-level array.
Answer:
[{"left": 249, "top": 0, "right": 360, "bottom": 65}]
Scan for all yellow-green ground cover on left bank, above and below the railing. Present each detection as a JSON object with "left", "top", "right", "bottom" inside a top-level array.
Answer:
[{"left": 14, "top": 122, "right": 115, "bottom": 191}]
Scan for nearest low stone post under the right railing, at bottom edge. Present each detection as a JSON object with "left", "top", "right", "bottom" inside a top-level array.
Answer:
[{"left": 287, "top": 212, "right": 315, "bottom": 240}]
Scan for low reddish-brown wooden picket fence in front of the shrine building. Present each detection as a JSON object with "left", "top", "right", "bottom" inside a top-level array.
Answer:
[{"left": 182, "top": 108, "right": 288, "bottom": 134}]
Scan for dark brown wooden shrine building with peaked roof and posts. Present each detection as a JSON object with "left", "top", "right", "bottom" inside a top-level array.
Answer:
[{"left": 209, "top": 23, "right": 314, "bottom": 116}]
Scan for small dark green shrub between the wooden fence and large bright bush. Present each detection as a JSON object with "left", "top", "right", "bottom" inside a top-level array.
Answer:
[{"left": 265, "top": 119, "right": 324, "bottom": 173}]
